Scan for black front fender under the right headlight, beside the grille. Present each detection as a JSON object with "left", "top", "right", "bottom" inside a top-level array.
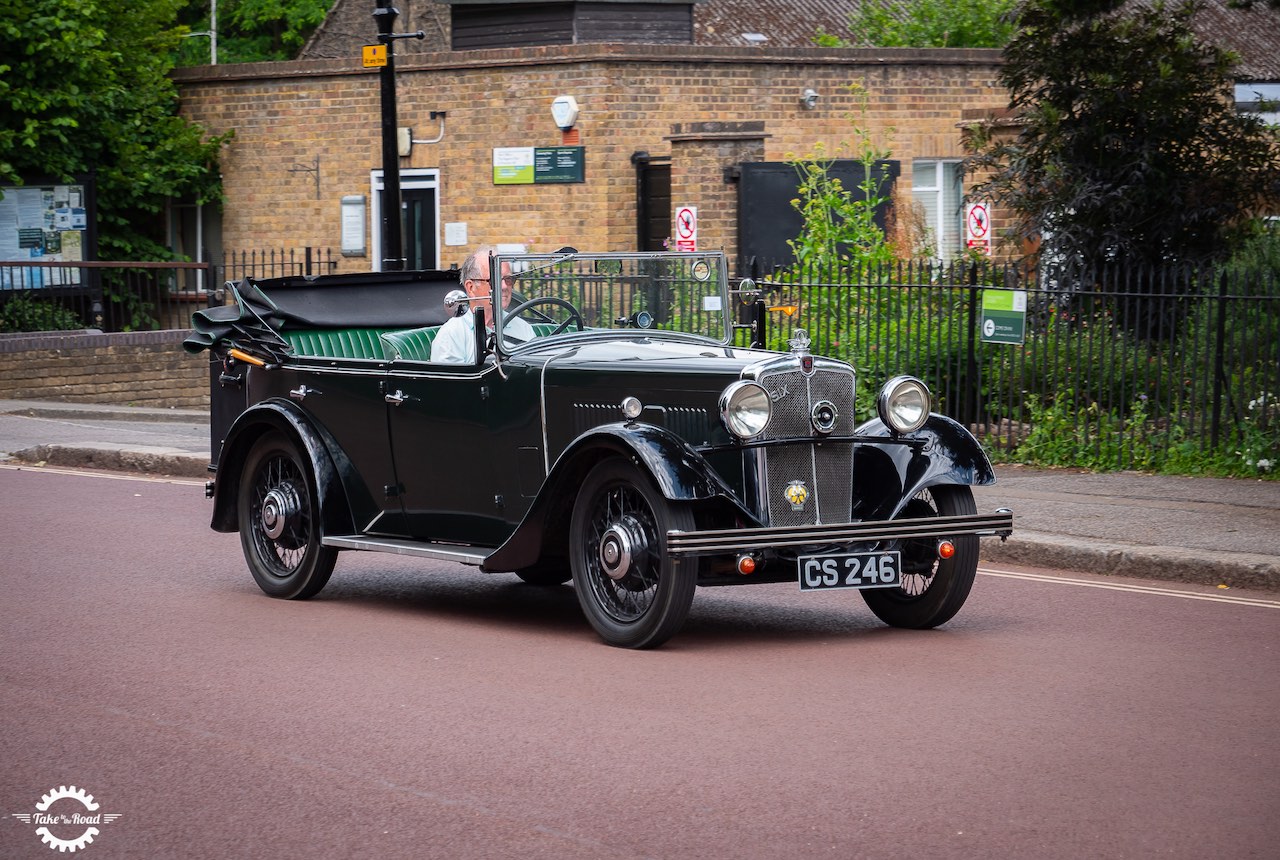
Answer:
[{"left": 854, "top": 413, "right": 996, "bottom": 520}]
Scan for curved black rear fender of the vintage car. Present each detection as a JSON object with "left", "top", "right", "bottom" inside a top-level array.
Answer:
[{"left": 210, "top": 398, "right": 355, "bottom": 535}]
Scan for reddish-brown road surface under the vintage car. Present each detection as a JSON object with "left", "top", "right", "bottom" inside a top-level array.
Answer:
[{"left": 0, "top": 467, "right": 1280, "bottom": 860}]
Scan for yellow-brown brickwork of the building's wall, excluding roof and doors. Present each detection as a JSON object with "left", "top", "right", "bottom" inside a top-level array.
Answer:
[{"left": 174, "top": 45, "right": 1007, "bottom": 271}]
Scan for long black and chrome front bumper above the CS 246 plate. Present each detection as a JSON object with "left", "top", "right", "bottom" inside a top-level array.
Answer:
[{"left": 667, "top": 511, "right": 1014, "bottom": 555}]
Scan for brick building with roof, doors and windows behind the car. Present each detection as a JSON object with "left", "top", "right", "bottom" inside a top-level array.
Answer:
[{"left": 175, "top": 0, "right": 1277, "bottom": 271}]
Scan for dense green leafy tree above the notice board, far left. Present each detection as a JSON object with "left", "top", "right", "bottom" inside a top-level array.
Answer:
[{"left": 0, "top": 0, "right": 224, "bottom": 260}]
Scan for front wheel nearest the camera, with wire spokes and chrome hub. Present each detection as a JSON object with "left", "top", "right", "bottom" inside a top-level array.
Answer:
[{"left": 570, "top": 458, "right": 698, "bottom": 648}]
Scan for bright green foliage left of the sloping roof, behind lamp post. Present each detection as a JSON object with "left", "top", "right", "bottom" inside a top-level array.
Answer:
[{"left": 178, "top": 0, "right": 335, "bottom": 65}]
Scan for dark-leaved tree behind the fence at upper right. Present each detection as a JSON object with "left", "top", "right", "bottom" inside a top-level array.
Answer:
[{"left": 966, "top": 0, "right": 1280, "bottom": 264}]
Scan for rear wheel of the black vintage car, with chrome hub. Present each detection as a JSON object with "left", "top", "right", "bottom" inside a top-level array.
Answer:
[{"left": 237, "top": 433, "right": 338, "bottom": 600}]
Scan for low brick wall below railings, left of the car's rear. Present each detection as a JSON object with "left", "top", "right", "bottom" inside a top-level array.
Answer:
[{"left": 0, "top": 330, "right": 209, "bottom": 408}]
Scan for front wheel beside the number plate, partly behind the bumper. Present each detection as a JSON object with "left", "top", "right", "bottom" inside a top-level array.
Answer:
[{"left": 860, "top": 485, "right": 978, "bottom": 630}]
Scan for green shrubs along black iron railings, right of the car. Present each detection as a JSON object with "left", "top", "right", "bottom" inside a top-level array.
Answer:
[{"left": 753, "top": 258, "right": 1280, "bottom": 475}]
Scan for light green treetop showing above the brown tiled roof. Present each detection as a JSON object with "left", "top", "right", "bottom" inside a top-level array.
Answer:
[{"left": 814, "top": 0, "right": 1018, "bottom": 47}]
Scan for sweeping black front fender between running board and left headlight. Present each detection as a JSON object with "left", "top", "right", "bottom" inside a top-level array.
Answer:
[{"left": 481, "top": 422, "right": 750, "bottom": 571}]
